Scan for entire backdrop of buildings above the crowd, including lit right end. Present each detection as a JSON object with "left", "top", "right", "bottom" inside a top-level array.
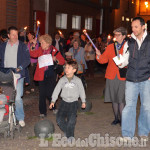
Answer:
[{"left": 0, "top": 0, "right": 150, "bottom": 37}]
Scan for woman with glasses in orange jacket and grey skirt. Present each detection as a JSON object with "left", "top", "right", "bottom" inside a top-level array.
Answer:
[{"left": 96, "top": 27, "right": 127, "bottom": 125}]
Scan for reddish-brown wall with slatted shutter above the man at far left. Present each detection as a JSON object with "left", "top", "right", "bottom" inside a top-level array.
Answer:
[{"left": 0, "top": 0, "right": 31, "bottom": 29}]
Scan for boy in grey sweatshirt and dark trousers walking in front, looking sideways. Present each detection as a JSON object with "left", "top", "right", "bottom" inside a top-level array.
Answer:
[{"left": 49, "top": 61, "right": 86, "bottom": 138}]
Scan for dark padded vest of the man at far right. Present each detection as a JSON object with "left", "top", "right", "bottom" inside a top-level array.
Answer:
[{"left": 126, "top": 34, "right": 150, "bottom": 82}]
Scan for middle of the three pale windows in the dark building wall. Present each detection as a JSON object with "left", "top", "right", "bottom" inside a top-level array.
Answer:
[{"left": 72, "top": 16, "right": 81, "bottom": 30}]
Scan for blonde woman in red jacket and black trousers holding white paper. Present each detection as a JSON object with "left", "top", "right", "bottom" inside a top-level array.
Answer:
[{"left": 30, "top": 34, "right": 65, "bottom": 117}]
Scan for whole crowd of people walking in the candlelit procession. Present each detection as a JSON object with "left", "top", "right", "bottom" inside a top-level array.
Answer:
[{"left": 0, "top": 17, "right": 150, "bottom": 140}]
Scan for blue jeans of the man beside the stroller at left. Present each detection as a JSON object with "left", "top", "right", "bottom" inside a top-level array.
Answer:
[{"left": 15, "top": 78, "right": 24, "bottom": 121}]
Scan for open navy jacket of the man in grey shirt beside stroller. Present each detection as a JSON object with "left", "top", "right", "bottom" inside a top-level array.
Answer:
[{"left": 0, "top": 41, "right": 30, "bottom": 77}]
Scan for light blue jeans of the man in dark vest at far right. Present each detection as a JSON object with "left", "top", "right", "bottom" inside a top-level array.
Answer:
[{"left": 122, "top": 80, "right": 150, "bottom": 138}]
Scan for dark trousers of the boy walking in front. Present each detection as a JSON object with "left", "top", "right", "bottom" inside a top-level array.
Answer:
[{"left": 56, "top": 100, "right": 78, "bottom": 138}]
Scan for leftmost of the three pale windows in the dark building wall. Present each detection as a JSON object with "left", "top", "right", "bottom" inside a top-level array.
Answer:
[{"left": 56, "top": 13, "right": 67, "bottom": 29}]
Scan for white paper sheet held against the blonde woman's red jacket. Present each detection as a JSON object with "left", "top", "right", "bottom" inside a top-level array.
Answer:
[{"left": 38, "top": 54, "right": 54, "bottom": 68}]
